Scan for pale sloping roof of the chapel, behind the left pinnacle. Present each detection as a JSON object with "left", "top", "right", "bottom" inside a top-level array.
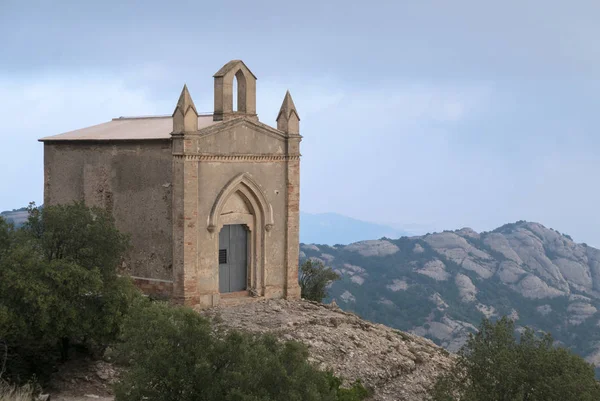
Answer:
[{"left": 39, "top": 114, "right": 220, "bottom": 142}]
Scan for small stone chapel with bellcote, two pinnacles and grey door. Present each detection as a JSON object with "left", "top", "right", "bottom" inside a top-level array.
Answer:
[{"left": 40, "top": 60, "right": 302, "bottom": 308}]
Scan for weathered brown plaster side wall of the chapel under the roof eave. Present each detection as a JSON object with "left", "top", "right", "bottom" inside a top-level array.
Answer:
[{"left": 44, "top": 141, "right": 172, "bottom": 282}]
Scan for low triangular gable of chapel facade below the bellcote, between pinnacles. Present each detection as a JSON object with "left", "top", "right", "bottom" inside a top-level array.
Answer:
[{"left": 192, "top": 118, "right": 286, "bottom": 155}]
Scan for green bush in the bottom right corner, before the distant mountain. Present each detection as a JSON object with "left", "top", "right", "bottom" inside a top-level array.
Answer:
[{"left": 431, "top": 317, "right": 600, "bottom": 401}]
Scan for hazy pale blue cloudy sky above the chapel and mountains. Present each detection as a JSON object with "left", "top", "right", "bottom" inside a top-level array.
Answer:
[{"left": 0, "top": 0, "right": 600, "bottom": 246}]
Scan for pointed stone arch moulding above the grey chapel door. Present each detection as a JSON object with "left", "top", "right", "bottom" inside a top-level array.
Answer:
[{"left": 207, "top": 173, "right": 273, "bottom": 233}]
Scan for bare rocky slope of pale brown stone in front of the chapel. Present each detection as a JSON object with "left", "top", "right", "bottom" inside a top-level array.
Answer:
[{"left": 202, "top": 300, "right": 453, "bottom": 401}]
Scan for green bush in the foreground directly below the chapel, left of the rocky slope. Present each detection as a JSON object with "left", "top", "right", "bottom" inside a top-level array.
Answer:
[{"left": 115, "top": 299, "right": 364, "bottom": 401}]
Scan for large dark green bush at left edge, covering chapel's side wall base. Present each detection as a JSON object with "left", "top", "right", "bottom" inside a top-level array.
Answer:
[{"left": 0, "top": 203, "right": 138, "bottom": 382}]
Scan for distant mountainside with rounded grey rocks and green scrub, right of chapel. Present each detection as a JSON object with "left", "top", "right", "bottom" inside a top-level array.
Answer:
[{"left": 301, "top": 221, "right": 600, "bottom": 364}]
